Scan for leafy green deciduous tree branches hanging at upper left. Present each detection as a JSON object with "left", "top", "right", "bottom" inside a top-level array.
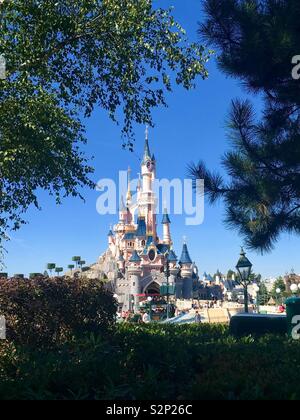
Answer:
[{"left": 0, "top": 0, "right": 208, "bottom": 249}]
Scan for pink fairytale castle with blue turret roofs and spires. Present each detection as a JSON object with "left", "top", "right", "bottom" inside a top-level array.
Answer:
[{"left": 89, "top": 129, "right": 199, "bottom": 312}]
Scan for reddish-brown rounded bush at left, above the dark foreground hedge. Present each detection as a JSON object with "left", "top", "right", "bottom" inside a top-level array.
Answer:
[{"left": 0, "top": 278, "right": 117, "bottom": 347}]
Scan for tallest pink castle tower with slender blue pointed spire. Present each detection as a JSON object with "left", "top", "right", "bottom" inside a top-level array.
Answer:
[{"left": 140, "top": 127, "right": 157, "bottom": 242}]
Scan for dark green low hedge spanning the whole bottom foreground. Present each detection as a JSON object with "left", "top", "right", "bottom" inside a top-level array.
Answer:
[{"left": 0, "top": 325, "right": 300, "bottom": 400}]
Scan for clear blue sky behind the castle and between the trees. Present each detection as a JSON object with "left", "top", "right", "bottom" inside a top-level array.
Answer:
[{"left": 5, "top": 0, "right": 300, "bottom": 276}]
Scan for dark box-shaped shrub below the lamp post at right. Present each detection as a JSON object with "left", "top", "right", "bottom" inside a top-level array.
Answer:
[{"left": 230, "top": 314, "right": 287, "bottom": 337}]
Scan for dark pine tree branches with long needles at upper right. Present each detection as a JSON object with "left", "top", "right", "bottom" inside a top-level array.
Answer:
[{"left": 190, "top": 0, "right": 300, "bottom": 252}]
